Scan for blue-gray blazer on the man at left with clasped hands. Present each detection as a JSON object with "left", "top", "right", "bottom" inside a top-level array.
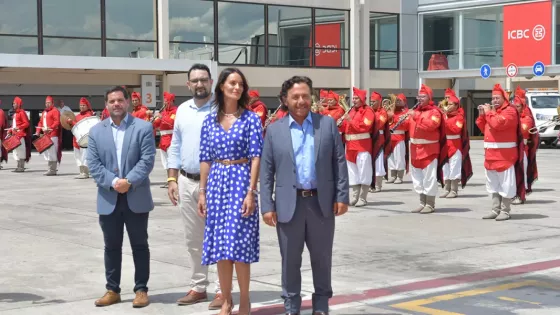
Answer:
[{"left": 87, "top": 114, "right": 156, "bottom": 214}]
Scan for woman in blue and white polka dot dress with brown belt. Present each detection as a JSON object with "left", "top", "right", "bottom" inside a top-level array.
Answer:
[{"left": 198, "top": 68, "right": 263, "bottom": 315}]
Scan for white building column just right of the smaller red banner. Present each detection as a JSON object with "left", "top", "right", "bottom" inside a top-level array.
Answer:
[{"left": 350, "top": 0, "right": 362, "bottom": 92}]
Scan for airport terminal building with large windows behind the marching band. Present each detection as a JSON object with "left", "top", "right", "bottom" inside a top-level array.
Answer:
[{"left": 0, "top": 0, "right": 560, "bottom": 139}]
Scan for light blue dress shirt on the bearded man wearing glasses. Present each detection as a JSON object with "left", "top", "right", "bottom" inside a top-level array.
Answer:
[{"left": 167, "top": 97, "right": 214, "bottom": 174}]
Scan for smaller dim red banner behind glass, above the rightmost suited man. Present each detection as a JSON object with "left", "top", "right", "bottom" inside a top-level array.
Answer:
[{"left": 314, "top": 23, "right": 342, "bottom": 67}]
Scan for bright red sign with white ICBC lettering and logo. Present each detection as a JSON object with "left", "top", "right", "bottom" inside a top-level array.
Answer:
[{"left": 503, "top": 1, "right": 552, "bottom": 67}]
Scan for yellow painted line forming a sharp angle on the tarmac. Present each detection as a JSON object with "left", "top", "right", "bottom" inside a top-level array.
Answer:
[{"left": 391, "top": 280, "right": 560, "bottom": 315}]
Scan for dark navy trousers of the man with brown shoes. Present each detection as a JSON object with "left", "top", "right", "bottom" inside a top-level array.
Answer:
[{"left": 99, "top": 194, "right": 150, "bottom": 293}]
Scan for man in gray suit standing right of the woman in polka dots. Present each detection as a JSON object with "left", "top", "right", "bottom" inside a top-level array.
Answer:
[{"left": 260, "top": 76, "right": 349, "bottom": 315}]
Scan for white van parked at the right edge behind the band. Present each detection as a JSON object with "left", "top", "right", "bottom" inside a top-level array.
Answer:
[{"left": 525, "top": 88, "right": 560, "bottom": 145}]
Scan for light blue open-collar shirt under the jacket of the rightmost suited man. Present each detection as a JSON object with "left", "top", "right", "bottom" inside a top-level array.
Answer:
[{"left": 288, "top": 113, "right": 317, "bottom": 189}]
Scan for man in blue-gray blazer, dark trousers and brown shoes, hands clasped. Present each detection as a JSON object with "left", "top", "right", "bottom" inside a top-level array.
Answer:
[{"left": 87, "top": 86, "right": 156, "bottom": 307}]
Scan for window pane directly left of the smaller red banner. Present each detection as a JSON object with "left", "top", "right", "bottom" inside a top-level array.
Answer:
[{"left": 268, "top": 6, "right": 312, "bottom": 67}]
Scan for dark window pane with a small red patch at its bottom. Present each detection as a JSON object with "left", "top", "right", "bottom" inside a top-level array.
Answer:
[{"left": 422, "top": 12, "right": 459, "bottom": 70}]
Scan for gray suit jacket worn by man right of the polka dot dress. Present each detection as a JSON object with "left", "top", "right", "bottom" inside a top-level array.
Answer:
[{"left": 260, "top": 113, "right": 349, "bottom": 223}]
